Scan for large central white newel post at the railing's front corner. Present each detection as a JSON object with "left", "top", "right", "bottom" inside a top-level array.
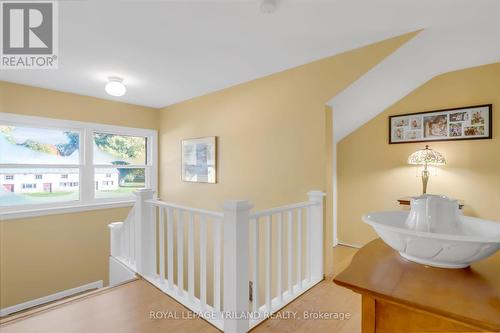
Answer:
[{"left": 223, "top": 200, "right": 253, "bottom": 333}]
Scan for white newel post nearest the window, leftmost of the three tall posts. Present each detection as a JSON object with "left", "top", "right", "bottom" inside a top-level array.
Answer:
[{"left": 134, "top": 189, "right": 156, "bottom": 277}]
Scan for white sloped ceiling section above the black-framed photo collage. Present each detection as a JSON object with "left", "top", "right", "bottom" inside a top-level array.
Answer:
[{"left": 328, "top": 2, "right": 500, "bottom": 142}]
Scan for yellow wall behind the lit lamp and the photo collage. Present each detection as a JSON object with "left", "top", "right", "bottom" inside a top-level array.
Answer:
[{"left": 334, "top": 63, "right": 500, "bottom": 244}]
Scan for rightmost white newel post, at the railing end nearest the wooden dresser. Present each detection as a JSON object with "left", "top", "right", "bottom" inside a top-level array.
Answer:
[{"left": 307, "top": 191, "right": 325, "bottom": 281}]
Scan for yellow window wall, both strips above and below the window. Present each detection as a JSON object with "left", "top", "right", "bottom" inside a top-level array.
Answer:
[{"left": 0, "top": 82, "right": 158, "bottom": 308}]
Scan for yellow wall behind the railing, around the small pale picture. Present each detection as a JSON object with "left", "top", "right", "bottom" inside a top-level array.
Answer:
[{"left": 160, "top": 34, "right": 414, "bottom": 272}]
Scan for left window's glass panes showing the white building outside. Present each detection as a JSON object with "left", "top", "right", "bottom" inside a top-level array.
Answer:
[{"left": 0, "top": 125, "right": 80, "bottom": 206}]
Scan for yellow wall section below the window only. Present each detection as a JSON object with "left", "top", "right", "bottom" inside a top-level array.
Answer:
[{"left": 0, "top": 208, "right": 130, "bottom": 308}]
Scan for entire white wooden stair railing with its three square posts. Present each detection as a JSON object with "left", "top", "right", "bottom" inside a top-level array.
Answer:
[{"left": 110, "top": 189, "right": 324, "bottom": 333}]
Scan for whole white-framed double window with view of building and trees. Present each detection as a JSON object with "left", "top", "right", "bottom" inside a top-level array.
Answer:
[{"left": 0, "top": 113, "right": 156, "bottom": 212}]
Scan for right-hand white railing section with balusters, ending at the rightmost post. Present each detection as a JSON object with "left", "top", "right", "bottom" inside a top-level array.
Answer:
[{"left": 249, "top": 191, "right": 324, "bottom": 328}]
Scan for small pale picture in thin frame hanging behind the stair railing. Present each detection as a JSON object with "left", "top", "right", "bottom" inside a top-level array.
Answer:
[{"left": 181, "top": 136, "right": 217, "bottom": 184}]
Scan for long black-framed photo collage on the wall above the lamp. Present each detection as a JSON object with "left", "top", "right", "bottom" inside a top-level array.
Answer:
[{"left": 389, "top": 104, "right": 493, "bottom": 144}]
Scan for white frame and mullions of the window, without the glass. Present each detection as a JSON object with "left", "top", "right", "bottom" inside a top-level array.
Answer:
[{"left": 0, "top": 112, "right": 158, "bottom": 220}]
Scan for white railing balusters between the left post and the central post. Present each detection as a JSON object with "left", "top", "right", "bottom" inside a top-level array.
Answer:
[{"left": 146, "top": 192, "right": 224, "bottom": 330}]
